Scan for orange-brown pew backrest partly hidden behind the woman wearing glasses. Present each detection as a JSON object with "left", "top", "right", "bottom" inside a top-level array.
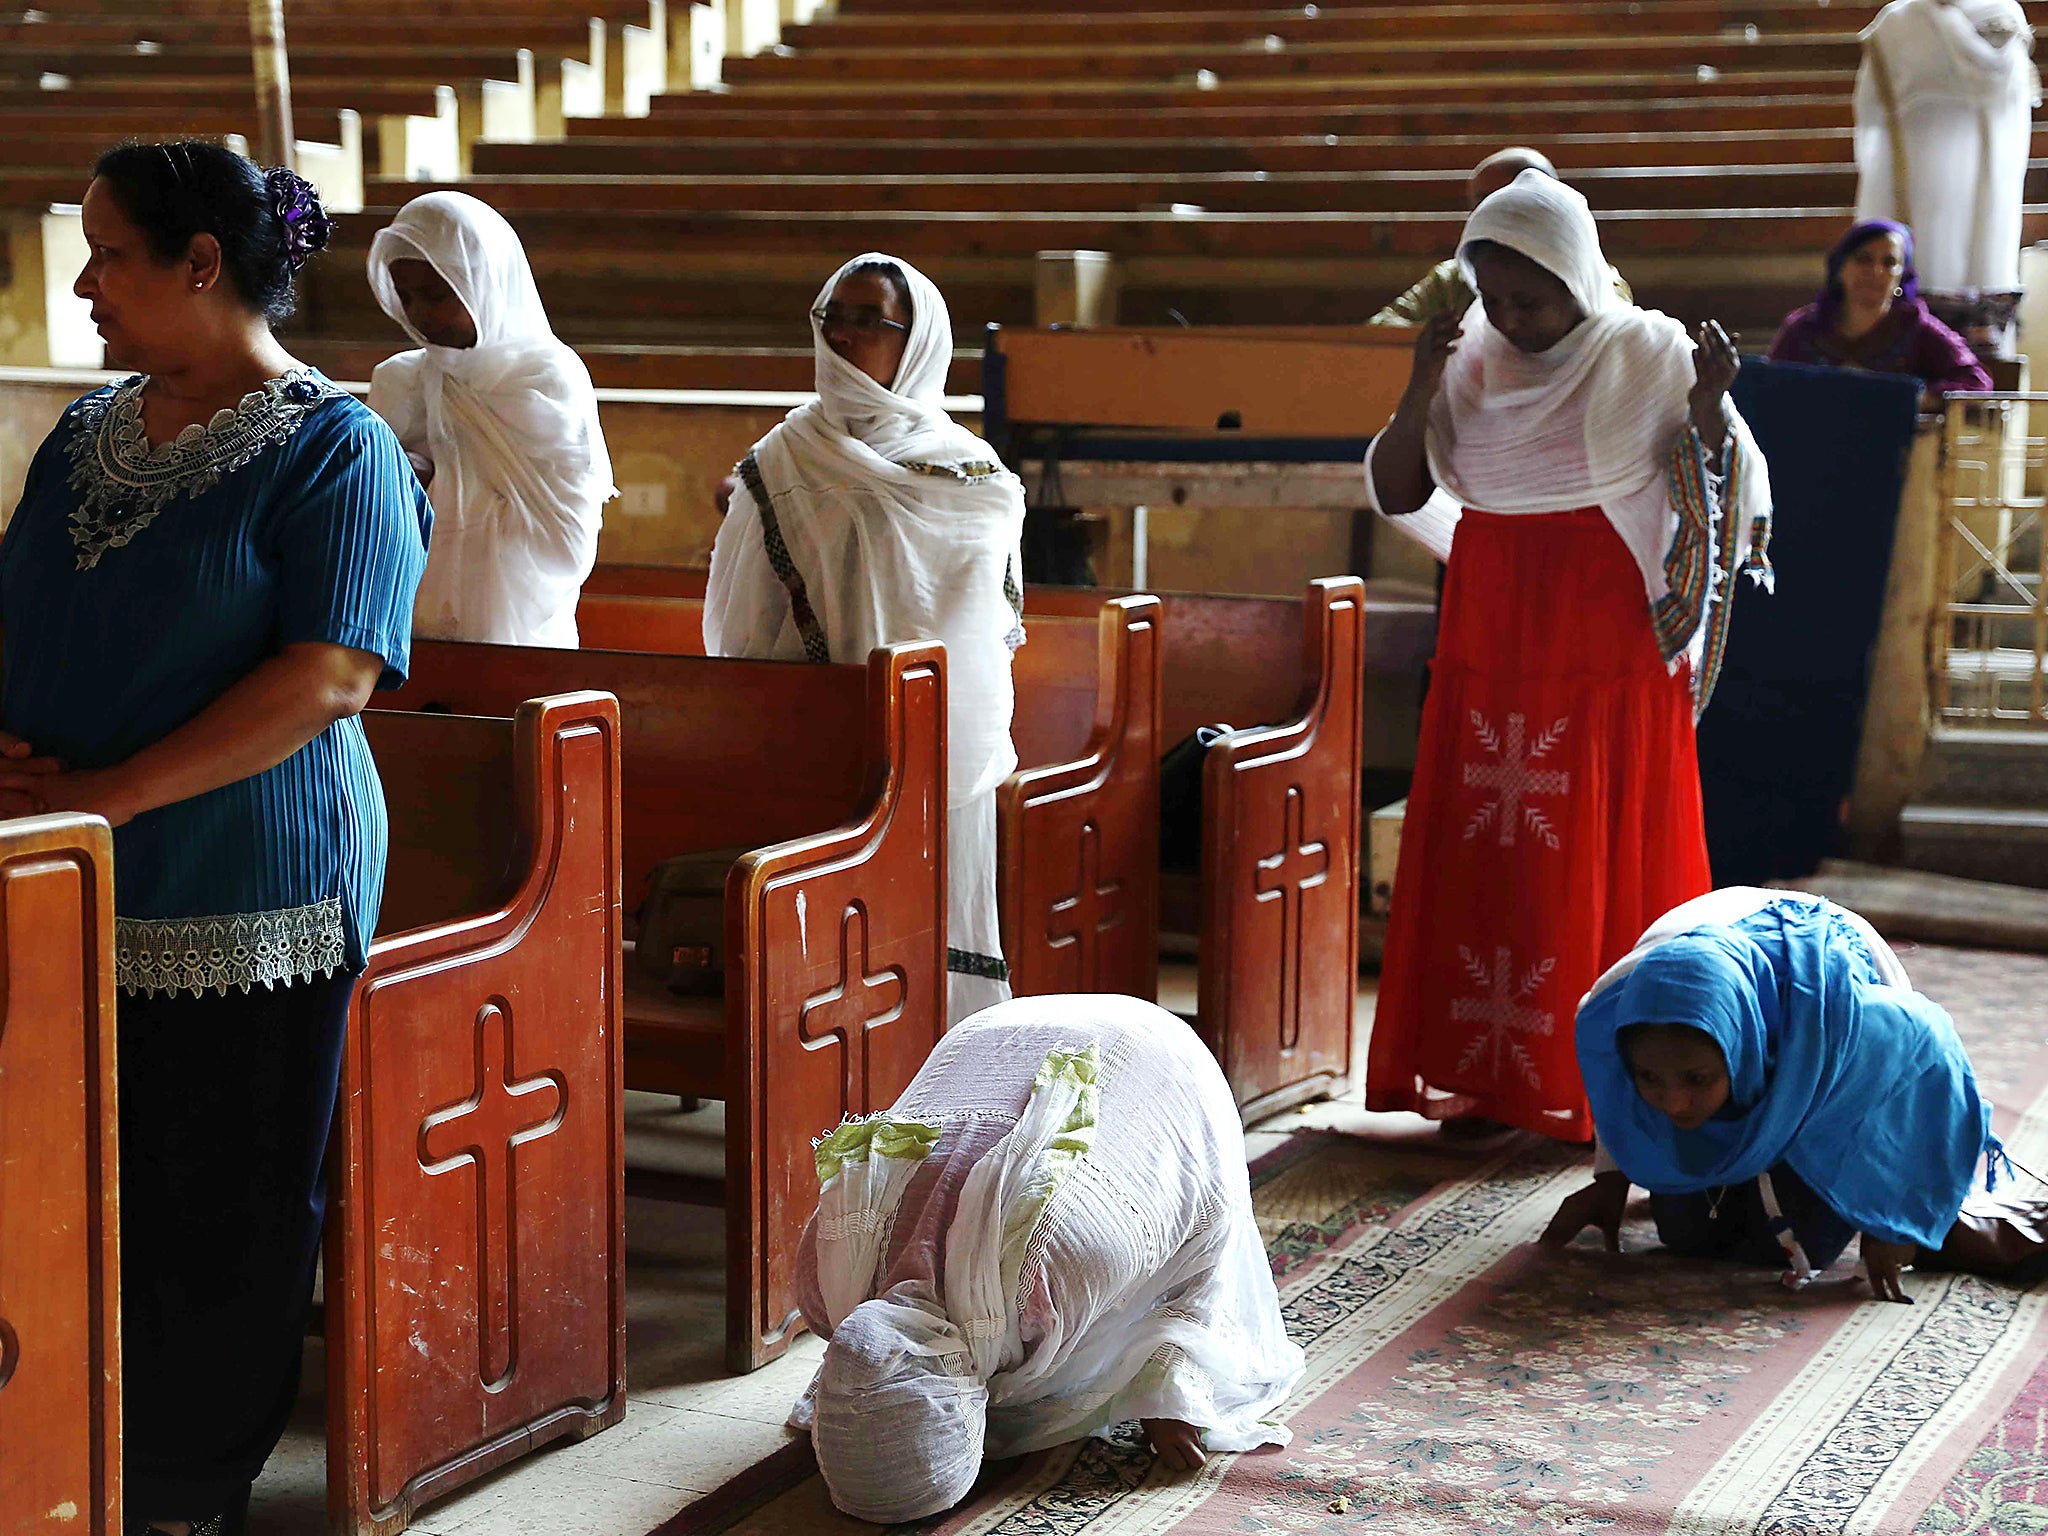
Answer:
[{"left": 575, "top": 589, "right": 1102, "bottom": 768}]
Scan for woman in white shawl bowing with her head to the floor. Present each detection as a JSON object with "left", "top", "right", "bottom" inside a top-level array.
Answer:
[{"left": 791, "top": 995, "right": 1303, "bottom": 1524}]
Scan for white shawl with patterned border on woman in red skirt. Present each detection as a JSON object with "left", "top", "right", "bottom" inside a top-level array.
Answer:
[{"left": 1427, "top": 170, "right": 1772, "bottom": 709}]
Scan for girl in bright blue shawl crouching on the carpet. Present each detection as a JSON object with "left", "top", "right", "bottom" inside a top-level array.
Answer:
[{"left": 1544, "top": 889, "right": 2048, "bottom": 1303}]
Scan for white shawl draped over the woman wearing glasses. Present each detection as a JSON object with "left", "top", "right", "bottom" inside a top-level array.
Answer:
[{"left": 705, "top": 252, "right": 1024, "bottom": 809}]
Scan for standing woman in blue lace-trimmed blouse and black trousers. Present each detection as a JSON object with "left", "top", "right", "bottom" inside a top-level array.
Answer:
[{"left": 0, "top": 143, "right": 430, "bottom": 1536}]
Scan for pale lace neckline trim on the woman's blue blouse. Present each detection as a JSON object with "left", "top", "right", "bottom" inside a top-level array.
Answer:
[{"left": 66, "top": 369, "right": 340, "bottom": 571}]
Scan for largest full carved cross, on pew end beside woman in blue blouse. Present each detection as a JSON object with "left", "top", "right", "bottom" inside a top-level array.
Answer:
[{"left": 420, "top": 1001, "right": 569, "bottom": 1391}]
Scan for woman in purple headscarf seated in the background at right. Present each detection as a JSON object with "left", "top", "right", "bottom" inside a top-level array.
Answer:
[{"left": 1769, "top": 219, "right": 1991, "bottom": 410}]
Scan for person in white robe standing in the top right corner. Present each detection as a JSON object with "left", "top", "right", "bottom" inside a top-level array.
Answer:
[{"left": 1855, "top": 0, "right": 2040, "bottom": 297}]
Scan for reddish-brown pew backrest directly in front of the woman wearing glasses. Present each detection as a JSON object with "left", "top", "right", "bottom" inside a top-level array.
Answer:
[{"left": 381, "top": 641, "right": 885, "bottom": 909}]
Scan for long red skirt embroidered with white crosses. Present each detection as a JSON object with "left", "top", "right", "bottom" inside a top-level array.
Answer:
[{"left": 1366, "top": 508, "right": 1712, "bottom": 1141}]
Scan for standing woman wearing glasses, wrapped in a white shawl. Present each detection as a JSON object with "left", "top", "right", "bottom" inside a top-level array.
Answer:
[{"left": 705, "top": 252, "right": 1024, "bottom": 1022}]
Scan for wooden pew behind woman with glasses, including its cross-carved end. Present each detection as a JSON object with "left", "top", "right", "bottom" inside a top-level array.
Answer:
[{"left": 575, "top": 581, "right": 1163, "bottom": 997}]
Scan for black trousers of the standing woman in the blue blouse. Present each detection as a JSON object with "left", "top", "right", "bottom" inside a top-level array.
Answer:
[{"left": 119, "top": 975, "right": 356, "bottom": 1528}]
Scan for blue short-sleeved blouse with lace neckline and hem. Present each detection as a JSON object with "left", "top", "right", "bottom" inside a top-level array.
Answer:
[{"left": 0, "top": 369, "right": 432, "bottom": 993}]
